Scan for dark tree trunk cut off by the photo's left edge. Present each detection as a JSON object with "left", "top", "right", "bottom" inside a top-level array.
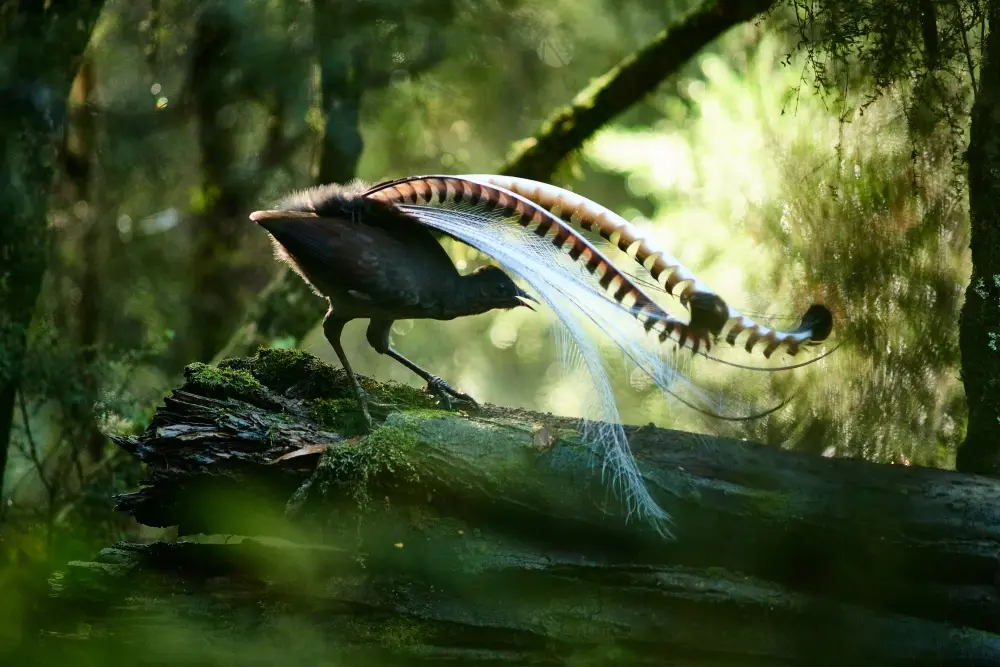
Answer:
[{"left": 0, "top": 0, "right": 104, "bottom": 498}]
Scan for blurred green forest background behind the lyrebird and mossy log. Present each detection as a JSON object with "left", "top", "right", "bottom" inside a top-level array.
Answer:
[{"left": 0, "top": 0, "right": 1000, "bottom": 655}]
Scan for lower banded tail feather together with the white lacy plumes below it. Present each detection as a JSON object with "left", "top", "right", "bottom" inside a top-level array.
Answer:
[{"left": 365, "top": 176, "right": 788, "bottom": 532}]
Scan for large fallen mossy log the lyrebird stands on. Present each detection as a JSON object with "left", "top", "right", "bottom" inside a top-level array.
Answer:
[{"left": 39, "top": 350, "right": 1000, "bottom": 667}]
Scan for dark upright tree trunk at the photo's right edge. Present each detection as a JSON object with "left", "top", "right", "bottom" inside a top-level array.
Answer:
[{"left": 956, "top": 0, "right": 1000, "bottom": 476}]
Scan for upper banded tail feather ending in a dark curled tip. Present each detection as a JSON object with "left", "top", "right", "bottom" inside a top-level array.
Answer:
[{"left": 459, "top": 174, "right": 833, "bottom": 358}]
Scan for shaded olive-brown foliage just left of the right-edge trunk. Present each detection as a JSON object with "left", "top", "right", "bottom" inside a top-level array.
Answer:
[{"left": 756, "top": 118, "right": 968, "bottom": 466}]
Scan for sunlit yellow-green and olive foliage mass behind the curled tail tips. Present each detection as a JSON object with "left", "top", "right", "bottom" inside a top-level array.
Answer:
[{"left": 589, "top": 37, "right": 968, "bottom": 466}]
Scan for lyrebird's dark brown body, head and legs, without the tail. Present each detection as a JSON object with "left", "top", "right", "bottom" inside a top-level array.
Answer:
[{"left": 250, "top": 182, "right": 534, "bottom": 424}]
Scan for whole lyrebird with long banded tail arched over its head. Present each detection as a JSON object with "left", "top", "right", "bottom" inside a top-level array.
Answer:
[{"left": 251, "top": 175, "right": 832, "bottom": 530}]
